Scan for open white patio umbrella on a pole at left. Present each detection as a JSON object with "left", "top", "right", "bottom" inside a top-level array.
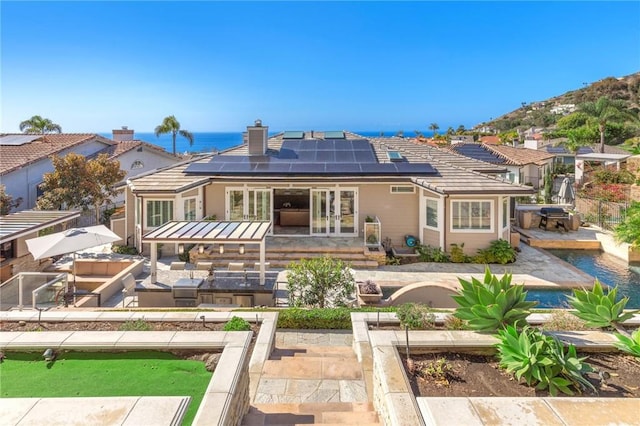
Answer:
[{"left": 26, "top": 225, "right": 121, "bottom": 283}]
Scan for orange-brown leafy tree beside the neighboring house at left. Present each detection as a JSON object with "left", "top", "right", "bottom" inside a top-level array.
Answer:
[{"left": 36, "top": 153, "right": 127, "bottom": 222}]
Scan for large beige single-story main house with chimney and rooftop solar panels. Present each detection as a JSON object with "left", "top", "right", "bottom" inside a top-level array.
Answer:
[{"left": 119, "top": 122, "right": 533, "bottom": 258}]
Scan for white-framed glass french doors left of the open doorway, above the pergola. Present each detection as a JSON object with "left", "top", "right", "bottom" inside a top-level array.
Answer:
[{"left": 226, "top": 188, "right": 273, "bottom": 220}]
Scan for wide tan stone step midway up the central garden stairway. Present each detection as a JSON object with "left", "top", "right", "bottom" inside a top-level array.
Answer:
[{"left": 262, "top": 356, "right": 362, "bottom": 380}]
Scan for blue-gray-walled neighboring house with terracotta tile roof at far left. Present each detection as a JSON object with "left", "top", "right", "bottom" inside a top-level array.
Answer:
[{"left": 0, "top": 133, "right": 115, "bottom": 211}]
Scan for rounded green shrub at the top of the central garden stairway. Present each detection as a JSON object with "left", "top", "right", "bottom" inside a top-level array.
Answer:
[{"left": 287, "top": 256, "right": 355, "bottom": 308}]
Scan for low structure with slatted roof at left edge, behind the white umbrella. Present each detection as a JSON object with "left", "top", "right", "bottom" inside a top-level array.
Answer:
[{"left": 0, "top": 210, "right": 80, "bottom": 283}]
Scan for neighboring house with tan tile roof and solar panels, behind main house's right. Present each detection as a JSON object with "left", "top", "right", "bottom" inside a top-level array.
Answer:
[{"left": 451, "top": 143, "right": 554, "bottom": 189}]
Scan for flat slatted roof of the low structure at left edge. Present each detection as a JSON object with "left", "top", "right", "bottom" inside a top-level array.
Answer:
[{"left": 0, "top": 210, "right": 80, "bottom": 244}]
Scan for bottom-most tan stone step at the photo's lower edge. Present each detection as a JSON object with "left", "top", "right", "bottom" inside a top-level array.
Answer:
[{"left": 242, "top": 402, "right": 380, "bottom": 426}]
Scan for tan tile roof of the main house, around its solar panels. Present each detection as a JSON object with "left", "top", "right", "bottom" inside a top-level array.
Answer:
[{"left": 128, "top": 132, "right": 533, "bottom": 195}]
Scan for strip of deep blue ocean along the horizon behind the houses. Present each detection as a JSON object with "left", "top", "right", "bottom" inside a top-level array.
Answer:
[{"left": 100, "top": 130, "right": 431, "bottom": 153}]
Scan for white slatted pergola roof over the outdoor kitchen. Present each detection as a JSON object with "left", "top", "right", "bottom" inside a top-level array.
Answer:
[{"left": 142, "top": 220, "right": 271, "bottom": 244}]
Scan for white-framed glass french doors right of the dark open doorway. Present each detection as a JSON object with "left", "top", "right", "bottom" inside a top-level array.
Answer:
[{"left": 311, "top": 188, "right": 358, "bottom": 236}]
